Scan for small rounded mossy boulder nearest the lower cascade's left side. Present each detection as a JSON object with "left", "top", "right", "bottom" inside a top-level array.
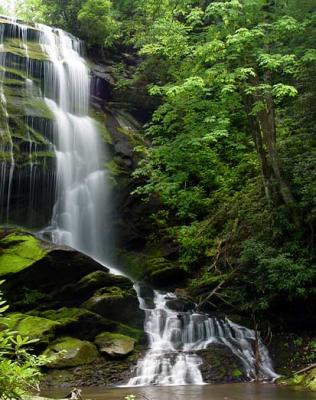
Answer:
[{"left": 95, "top": 332, "right": 136, "bottom": 358}]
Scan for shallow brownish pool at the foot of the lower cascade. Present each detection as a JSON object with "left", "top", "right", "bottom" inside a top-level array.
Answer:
[{"left": 42, "top": 384, "right": 316, "bottom": 400}]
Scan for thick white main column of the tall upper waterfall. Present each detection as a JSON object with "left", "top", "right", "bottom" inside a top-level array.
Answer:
[{"left": 34, "top": 25, "right": 108, "bottom": 261}]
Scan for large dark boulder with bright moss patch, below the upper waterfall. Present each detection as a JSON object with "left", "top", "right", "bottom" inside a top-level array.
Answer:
[{"left": 0, "top": 230, "right": 110, "bottom": 312}]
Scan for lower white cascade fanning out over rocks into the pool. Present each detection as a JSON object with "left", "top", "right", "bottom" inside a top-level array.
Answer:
[{"left": 129, "top": 285, "right": 278, "bottom": 386}]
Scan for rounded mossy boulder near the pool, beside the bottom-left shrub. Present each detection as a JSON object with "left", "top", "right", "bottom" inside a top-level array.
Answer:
[{"left": 43, "top": 337, "right": 99, "bottom": 368}]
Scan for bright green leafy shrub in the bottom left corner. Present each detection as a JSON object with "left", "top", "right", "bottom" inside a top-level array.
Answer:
[{"left": 0, "top": 281, "right": 43, "bottom": 399}]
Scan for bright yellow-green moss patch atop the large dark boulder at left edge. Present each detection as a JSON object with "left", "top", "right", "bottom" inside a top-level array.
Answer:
[{"left": 0, "top": 233, "right": 46, "bottom": 277}]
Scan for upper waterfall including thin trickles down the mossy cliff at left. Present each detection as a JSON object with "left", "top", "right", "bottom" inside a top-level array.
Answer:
[{"left": 0, "top": 14, "right": 109, "bottom": 261}]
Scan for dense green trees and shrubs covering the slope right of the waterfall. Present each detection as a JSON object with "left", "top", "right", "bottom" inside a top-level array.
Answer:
[{"left": 4, "top": 0, "right": 316, "bottom": 324}]
